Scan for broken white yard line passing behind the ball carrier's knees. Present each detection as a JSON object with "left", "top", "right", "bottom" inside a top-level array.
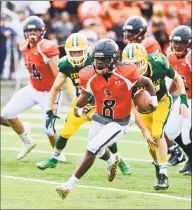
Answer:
[{"left": 1, "top": 131, "right": 148, "bottom": 147}]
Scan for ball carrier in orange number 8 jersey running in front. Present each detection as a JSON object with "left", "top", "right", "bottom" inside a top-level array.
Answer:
[{"left": 56, "top": 39, "right": 157, "bottom": 199}]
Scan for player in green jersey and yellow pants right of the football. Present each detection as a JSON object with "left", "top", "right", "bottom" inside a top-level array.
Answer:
[{"left": 122, "top": 43, "right": 188, "bottom": 190}]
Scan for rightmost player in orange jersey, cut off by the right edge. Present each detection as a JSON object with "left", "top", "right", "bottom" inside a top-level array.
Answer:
[{"left": 166, "top": 25, "right": 192, "bottom": 175}]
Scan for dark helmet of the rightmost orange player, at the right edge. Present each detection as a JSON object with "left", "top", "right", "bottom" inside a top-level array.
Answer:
[{"left": 170, "top": 25, "right": 192, "bottom": 57}]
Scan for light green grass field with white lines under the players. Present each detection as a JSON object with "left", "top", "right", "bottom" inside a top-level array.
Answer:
[{"left": 1, "top": 109, "right": 191, "bottom": 209}]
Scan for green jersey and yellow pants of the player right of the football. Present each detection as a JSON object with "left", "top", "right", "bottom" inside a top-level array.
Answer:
[{"left": 140, "top": 52, "right": 175, "bottom": 138}]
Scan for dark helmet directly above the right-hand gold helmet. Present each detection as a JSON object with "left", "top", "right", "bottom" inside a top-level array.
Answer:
[{"left": 123, "top": 16, "right": 147, "bottom": 43}]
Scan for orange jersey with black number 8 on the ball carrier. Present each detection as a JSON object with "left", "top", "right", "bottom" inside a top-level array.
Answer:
[{"left": 79, "top": 63, "right": 140, "bottom": 120}]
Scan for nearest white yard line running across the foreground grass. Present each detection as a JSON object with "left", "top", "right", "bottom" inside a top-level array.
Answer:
[{"left": 1, "top": 175, "right": 191, "bottom": 201}]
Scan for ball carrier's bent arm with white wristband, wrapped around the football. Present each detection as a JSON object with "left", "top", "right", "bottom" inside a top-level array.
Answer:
[{"left": 133, "top": 75, "right": 158, "bottom": 113}]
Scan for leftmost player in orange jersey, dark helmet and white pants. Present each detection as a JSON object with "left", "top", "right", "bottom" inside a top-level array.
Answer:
[{"left": 3, "top": 16, "right": 64, "bottom": 160}]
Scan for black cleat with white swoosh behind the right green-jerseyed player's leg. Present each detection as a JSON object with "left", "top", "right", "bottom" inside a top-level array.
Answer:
[{"left": 168, "top": 146, "right": 186, "bottom": 166}]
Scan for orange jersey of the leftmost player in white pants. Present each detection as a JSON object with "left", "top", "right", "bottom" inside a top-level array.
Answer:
[{"left": 20, "top": 39, "right": 59, "bottom": 91}]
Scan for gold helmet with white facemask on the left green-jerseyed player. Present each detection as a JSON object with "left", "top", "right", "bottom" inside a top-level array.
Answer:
[{"left": 65, "top": 33, "right": 88, "bottom": 66}]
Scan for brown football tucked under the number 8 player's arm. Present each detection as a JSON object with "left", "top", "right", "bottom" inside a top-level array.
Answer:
[{"left": 133, "top": 89, "right": 151, "bottom": 112}]
